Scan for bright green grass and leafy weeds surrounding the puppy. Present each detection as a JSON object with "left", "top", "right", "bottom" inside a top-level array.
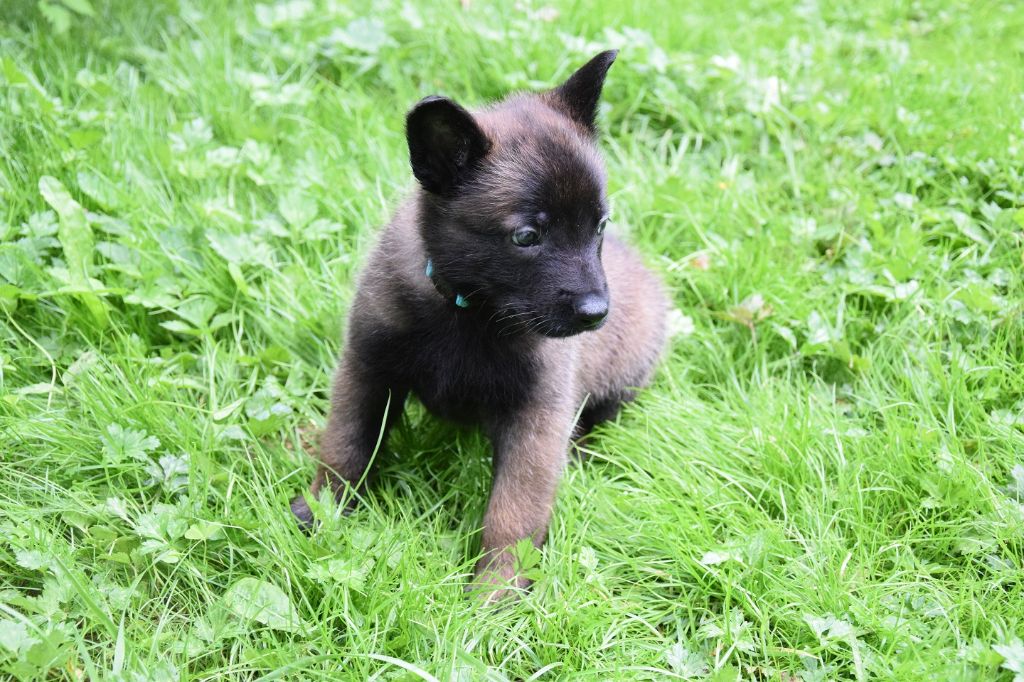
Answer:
[{"left": 0, "top": 0, "right": 1024, "bottom": 682}]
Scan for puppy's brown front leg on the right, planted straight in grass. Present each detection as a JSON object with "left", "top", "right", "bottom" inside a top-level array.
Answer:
[{"left": 473, "top": 400, "right": 574, "bottom": 601}]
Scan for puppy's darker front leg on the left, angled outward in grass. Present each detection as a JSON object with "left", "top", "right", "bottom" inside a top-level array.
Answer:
[{"left": 292, "top": 350, "right": 407, "bottom": 526}]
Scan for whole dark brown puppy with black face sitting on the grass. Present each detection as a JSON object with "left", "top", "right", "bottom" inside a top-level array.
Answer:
[{"left": 292, "top": 51, "right": 668, "bottom": 599}]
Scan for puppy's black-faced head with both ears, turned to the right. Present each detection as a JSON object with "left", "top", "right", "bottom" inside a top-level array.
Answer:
[{"left": 406, "top": 50, "right": 615, "bottom": 337}]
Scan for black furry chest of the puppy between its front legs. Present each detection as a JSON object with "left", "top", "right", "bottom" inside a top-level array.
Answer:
[{"left": 394, "top": 325, "right": 538, "bottom": 422}]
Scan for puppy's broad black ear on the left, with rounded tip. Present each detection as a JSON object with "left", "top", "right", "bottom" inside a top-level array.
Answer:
[{"left": 406, "top": 95, "right": 490, "bottom": 195}]
